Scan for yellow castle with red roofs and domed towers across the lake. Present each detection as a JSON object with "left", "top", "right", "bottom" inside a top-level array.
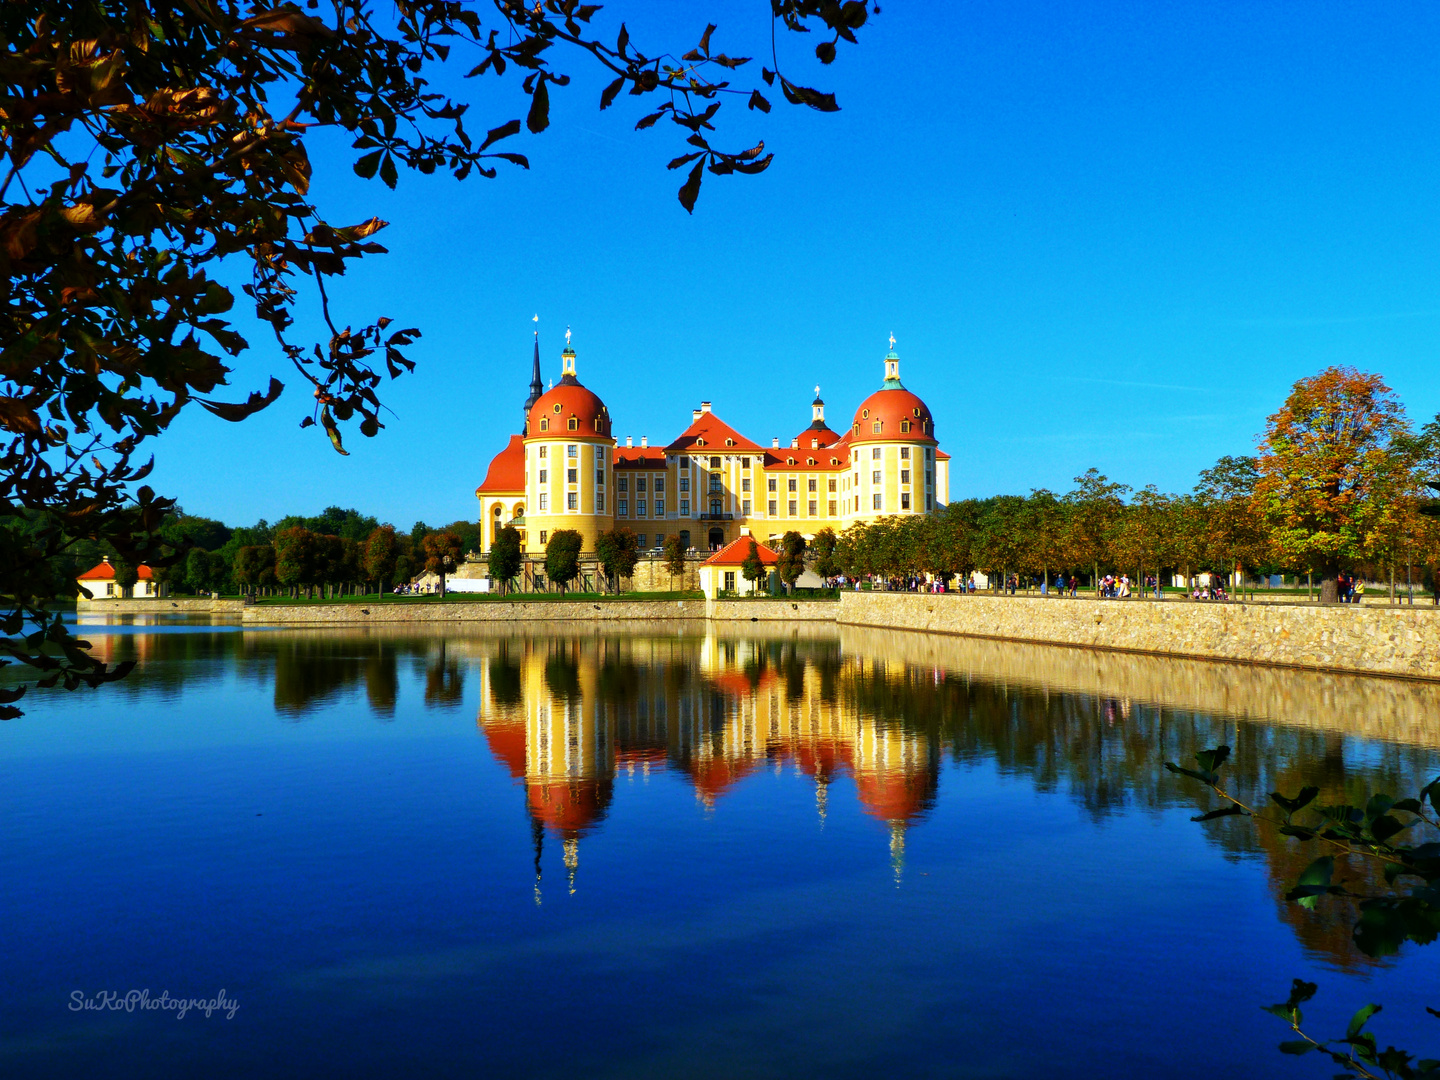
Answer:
[{"left": 475, "top": 331, "right": 950, "bottom": 557}]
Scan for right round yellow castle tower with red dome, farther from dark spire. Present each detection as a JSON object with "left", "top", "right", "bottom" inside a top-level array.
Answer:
[{"left": 844, "top": 334, "right": 937, "bottom": 521}]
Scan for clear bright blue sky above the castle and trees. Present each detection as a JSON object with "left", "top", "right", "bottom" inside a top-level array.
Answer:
[{"left": 146, "top": 0, "right": 1440, "bottom": 526}]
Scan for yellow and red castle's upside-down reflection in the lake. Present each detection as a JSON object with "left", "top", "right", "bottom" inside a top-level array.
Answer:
[{"left": 477, "top": 635, "right": 940, "bottom": 888}]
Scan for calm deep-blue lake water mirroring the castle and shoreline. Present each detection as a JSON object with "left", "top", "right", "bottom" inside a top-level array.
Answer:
[{"left": 0, "top": 624, "right": 1440, "bottom": 1080}]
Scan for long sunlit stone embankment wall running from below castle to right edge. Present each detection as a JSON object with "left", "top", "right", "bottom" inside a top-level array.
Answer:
[{"left": 840, "top": 592, "right": 1440, "bottom": 680}]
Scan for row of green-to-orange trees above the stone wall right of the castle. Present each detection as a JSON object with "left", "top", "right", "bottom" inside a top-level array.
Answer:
[{"left": 834, "top": 367, "right": 1440, "bottom": 600}]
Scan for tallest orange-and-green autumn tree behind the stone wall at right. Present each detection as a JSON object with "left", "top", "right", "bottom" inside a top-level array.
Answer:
[{"left": 1254, "top": 367, "right": 1413, "bottom": 602}]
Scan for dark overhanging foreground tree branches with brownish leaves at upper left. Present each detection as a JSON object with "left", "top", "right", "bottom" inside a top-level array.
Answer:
[{"left": 0, "top": 0, "right": 868, "bottom": 716}]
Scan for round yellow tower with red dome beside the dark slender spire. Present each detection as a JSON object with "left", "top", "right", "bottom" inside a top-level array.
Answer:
[{"left": 524, "top": 330, "right": 615, "bottom": 553}]
